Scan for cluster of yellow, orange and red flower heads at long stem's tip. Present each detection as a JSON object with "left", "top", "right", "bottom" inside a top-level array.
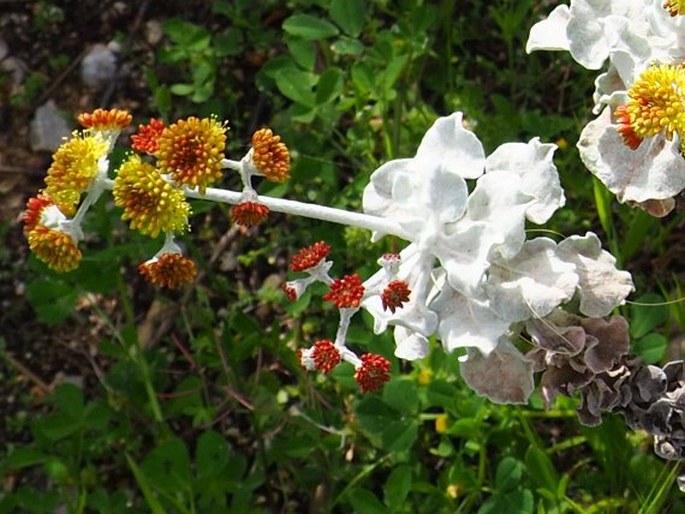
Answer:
[{"left": 24, "top": 109, "right": 290, "bottom": 287}]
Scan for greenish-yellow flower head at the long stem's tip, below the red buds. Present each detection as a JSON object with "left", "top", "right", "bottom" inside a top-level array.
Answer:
[{"left": 113, "top": 155, "right": 190, "bottom": 237}]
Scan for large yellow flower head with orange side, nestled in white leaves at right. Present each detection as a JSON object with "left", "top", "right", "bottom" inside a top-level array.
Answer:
[{"left": 618, "top": 64, "right": 685, "bottom": 148}]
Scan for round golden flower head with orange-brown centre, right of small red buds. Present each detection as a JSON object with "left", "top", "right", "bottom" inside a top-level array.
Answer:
[{"left": 155, "top": 116, "right": 226, "bottom": 193}]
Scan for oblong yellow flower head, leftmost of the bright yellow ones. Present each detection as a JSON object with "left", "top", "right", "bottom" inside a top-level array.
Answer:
[{"left": 45, "top": 132, "right": 109, "bottom": 216}]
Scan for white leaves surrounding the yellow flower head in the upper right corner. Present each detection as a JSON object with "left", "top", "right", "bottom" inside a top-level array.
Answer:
[{"left": 526, "top": 0, "right": 685, "bottom": 212}]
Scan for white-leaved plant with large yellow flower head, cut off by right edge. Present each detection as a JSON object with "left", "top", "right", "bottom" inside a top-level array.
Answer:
[{"left": 527, "top": 0, "right": 685, "bottom": 216}]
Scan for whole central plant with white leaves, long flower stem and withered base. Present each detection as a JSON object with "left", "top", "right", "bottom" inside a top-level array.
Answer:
[{"left": 23, "top": 106, "right": 685, "bottom": 466}]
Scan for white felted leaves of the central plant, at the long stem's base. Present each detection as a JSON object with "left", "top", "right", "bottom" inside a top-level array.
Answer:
[{"left": 362, "top": 113, "right": 632, "bottom": 402}]
